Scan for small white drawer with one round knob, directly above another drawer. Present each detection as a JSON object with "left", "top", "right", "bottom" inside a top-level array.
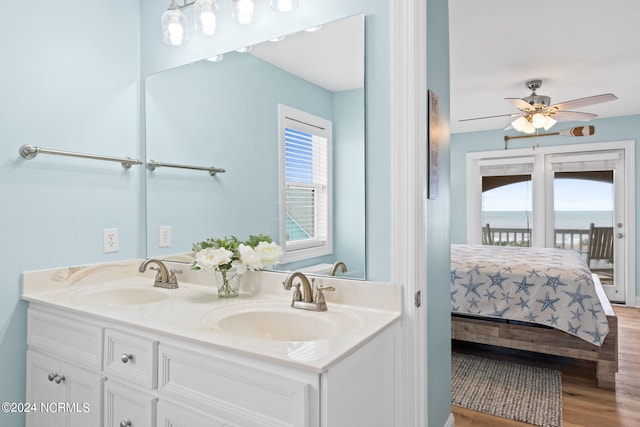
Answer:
[{"left": 104, "top": 328, "right": 158, "bottom": 388}]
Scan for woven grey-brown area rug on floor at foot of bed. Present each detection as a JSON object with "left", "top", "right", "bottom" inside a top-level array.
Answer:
[{"left": 451, "top": 352, "right": 562, "bottom": 427}]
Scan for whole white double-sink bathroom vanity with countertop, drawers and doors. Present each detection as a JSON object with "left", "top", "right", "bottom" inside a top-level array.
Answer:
[{"left": 23, "top": 260, "right": 401, "bottom": 427}]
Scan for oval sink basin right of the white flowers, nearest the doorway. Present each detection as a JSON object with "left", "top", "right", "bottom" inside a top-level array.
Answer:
[{"left": 202, "top": 301, "right": 362, "bottom": 342}]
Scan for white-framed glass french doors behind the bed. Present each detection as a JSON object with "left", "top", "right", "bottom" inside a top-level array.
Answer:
[{"left": 467, "top": 141, "right": 636, "bottom": 305}]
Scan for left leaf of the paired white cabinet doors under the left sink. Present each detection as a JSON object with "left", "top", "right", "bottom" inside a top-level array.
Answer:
[{"left": 26, "top": 351, "right": 64, "bottom": 427}]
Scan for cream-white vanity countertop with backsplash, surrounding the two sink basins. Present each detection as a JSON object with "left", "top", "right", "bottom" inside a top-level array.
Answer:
[{"left": 22, "top": 260, "right": 402, "bottom": 373}]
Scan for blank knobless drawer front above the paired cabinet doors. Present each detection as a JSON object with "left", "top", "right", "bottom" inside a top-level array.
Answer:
[{"left": 27, "top": 308, "right": 102, "bottom": 371}]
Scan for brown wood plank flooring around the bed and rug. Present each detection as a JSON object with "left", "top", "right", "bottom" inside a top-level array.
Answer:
[{"left": 451, "top": 306, "right": 640, "bottom": 427}]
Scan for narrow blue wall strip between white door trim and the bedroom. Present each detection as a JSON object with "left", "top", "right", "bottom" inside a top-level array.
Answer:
[{"left": 427, "top": 0, "right": 451, "bottom": 426}]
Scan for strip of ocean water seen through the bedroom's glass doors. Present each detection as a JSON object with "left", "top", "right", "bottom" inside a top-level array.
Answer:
[{"left": 482, "top": 211, "right": 613, "bottom": 230}]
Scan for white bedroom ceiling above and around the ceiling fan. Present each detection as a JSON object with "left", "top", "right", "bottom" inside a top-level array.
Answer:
[{"left": 449, "top": 0, "right": 640, "bottom": 133}]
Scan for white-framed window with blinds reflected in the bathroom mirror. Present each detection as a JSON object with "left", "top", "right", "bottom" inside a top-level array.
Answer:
[{"left": 280, "top": 106, "right": 331, "bottom": 262}]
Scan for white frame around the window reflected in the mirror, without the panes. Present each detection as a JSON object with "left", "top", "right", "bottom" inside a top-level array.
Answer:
[{"left": 278, "top": 104, "right": 333, "bottom": 264}]
